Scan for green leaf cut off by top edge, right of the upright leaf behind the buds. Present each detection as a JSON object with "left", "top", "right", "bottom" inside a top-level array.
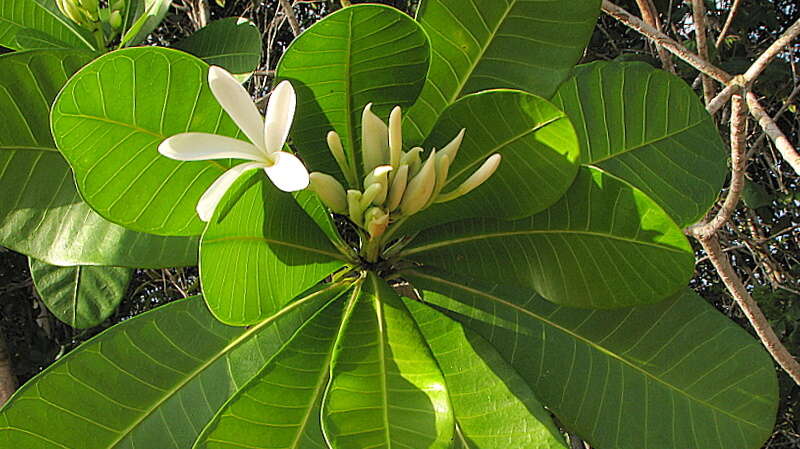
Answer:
[{"left": 404, "top": 0, "right": 600, "bottom": 144}]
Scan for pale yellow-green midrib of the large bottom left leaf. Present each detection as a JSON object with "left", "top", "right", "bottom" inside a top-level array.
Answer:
[{"left": 108, "top": 283, "right": 343, "bottom": 448}]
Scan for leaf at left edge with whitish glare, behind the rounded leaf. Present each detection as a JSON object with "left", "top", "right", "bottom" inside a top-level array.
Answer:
[{"left": 0, "top": 50, "right": 197, "bottom": 267}]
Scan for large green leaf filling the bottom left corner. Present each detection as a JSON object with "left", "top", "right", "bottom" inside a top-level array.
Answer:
[{"left": 0, "top": 285, "right": 346, "bottom": 449}]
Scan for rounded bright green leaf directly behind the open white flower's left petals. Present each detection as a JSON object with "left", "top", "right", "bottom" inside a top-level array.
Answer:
[{"left": 52, "top": 47, "right": 247, "bottom": 235}]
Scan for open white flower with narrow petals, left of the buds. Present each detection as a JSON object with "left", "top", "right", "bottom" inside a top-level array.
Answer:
[{"left": 158, "top": 66, "right": 309, "bottom": 221}]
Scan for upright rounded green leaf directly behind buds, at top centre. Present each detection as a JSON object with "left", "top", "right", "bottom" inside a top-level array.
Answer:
[{"left": 277, "top": 5, "right": 430, "bottom": 182}]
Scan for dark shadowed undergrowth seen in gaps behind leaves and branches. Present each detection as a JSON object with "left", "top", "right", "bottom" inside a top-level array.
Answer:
[{"left": 0, "top": 0, "right": 800, "bottom": 448}]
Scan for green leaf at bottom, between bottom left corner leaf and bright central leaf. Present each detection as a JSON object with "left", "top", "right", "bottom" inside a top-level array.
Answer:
[{"left": 194, "top": 288, "right": 346, "bottom": 449}]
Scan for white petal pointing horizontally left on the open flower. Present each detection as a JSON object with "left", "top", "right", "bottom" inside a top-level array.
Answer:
[{"left": 158, "top": 133, "right": 266, "bottom": 162}]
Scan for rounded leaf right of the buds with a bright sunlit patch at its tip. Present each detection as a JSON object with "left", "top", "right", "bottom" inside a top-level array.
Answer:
[{"left": 396, "top": 90, "right": 579, "bottom": 232}]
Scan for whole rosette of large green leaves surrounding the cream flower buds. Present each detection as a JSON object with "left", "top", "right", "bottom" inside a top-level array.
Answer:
[{"left": 0, "top": 0, "right": 777, "bottom": 449}]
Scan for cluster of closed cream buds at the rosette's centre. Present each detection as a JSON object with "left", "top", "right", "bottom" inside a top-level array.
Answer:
[{"left": 310, "top": 104, "right": 500, "bottom": 238}]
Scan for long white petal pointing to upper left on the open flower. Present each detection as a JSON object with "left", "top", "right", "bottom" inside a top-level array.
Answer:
[{"left": 208, "top": 66, "right": 264, "bottom": 148}]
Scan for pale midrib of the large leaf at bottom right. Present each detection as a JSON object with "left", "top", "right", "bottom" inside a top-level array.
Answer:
[{"left": 406, "top": 270, "right": 769, "bottom": 430}]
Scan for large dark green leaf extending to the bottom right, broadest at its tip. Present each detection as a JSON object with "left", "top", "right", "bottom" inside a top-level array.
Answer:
[{"left": 405, "top": 272, "right": 778, "bottom": 449}]
